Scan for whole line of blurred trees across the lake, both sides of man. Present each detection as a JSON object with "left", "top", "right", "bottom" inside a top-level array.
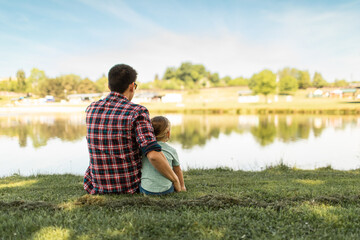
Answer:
[{"left": 0, "top": 62, "right": 349, "bottom": 99}]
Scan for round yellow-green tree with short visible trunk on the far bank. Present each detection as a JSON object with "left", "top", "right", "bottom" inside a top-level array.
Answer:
[{"left": 249, "top": 70, "right": 276, "bottom": 100}]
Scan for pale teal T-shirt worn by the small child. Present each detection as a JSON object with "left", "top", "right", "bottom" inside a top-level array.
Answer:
[{"left": 141, "top": 141, "right": 180, "bottom": 192}]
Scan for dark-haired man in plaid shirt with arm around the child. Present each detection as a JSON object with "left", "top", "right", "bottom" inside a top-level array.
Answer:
[{"left": 84, "top": 64, "right": 181, "bottom": 194}]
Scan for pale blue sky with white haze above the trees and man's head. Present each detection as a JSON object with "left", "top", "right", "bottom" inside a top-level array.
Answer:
[{"left": 0, "top": 0, "right": 360, "bottom": 82}]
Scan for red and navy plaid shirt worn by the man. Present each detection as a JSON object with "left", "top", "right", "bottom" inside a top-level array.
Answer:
[{"left": 84, "top": 92, "right": 158, "bottom": 194}]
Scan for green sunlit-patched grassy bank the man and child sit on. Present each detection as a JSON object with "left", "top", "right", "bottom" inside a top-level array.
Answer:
[{"left": 0, "top": 165, "right": 360, "bottom": 239}]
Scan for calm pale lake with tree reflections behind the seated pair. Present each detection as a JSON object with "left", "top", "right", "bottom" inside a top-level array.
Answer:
[{"left": 0, "top": 113, "right": 360, "bottom": 177}]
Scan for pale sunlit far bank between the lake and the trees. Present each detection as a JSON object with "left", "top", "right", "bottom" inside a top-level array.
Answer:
[{"left": 0, "top": 87, "right": 360, "bottom": 115}]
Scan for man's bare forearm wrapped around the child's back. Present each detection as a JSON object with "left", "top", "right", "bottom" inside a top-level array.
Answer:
[{"left": 146, "top": 151, "right": 181, "bottom": 192}]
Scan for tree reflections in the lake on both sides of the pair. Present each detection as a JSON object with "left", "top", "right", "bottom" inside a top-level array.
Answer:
[{"left": 0, "top": 113, "right": 360, "bottom": 149}]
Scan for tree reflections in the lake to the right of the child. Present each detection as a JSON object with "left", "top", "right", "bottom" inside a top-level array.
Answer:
[{"left": 170, "top": 115, "right": 360, "bottom": 149}]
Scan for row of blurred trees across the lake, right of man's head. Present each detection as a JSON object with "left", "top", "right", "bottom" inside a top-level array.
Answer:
[{"left": 142, "top": 62, "right": 349, "bottom": 95}]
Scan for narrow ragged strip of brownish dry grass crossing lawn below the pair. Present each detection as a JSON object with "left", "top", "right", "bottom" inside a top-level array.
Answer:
[{"left": 0, "top": 195, "right": 360, "bottom": 210}]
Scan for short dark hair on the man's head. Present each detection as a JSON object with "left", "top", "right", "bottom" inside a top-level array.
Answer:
[{"left": 108, "top": 64, "right": 137, "bottom": 93}]
